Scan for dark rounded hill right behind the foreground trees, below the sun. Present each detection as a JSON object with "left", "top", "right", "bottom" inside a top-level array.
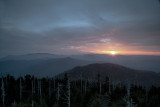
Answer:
[{"left": 56, "top": 63, "right": 160, "bottom": 86}]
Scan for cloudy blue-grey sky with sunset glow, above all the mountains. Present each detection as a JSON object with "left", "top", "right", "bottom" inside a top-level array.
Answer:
[{"left": 0, "top": 0, "right": 160, "bottom": 56}]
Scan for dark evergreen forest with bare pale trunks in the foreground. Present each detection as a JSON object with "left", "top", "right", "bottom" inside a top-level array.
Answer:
[{"left": 0, "top": 74, "right": 160, "bottom": 107}]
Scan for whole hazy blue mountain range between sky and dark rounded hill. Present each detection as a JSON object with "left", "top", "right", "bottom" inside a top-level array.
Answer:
[{"left": 0, "top": 53, "right": 160, "bottom": 77}]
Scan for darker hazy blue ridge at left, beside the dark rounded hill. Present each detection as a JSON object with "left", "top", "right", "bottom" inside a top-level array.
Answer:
[{"left": 0, "top": 57, "right": 92, "bottom": 77}]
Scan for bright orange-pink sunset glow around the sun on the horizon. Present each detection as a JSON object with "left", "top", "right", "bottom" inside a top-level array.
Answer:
[{"left": 71, "top": 43, "right": 160, "bottom": 56}]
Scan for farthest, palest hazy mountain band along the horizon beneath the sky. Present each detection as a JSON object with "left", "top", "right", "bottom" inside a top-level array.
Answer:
[{"left": 0, "top": 53, "right": 160, "bottom": 72}]
